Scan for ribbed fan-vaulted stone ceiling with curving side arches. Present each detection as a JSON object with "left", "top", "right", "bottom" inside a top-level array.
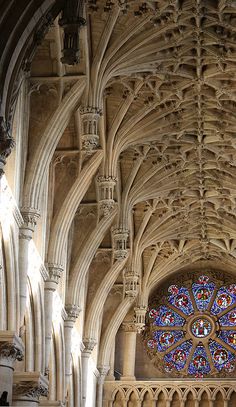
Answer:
[{"left": 6, "top": 0, "right": 236, "bottom": 354}]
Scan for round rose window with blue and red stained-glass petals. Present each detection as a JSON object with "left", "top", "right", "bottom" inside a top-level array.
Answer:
[{"left": 144, "top": 275, "right": 236, "bottom": 378}]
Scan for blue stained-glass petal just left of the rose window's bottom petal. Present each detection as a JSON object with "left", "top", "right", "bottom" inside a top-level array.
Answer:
[{"left": 164, "top": 340, "right": 192, "bottom": 371}]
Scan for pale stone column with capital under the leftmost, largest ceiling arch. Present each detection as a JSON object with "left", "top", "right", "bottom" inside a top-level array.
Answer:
[{"left": 19, "top": 208, "right": 39, "bottom": 328}]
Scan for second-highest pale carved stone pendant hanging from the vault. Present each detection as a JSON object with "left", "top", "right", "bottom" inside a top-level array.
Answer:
[{"left": 97, "top": 175, "right": 117, "bottom": 216}]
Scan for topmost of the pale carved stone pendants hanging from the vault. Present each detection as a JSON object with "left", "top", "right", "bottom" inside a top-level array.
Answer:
[{"left": 80, "top": 106, "right": 101, "bottom": 152}]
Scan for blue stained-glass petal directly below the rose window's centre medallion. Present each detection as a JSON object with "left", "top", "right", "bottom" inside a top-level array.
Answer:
[{"left": 188, "top": 345, "right": 211, "bottom": 375}]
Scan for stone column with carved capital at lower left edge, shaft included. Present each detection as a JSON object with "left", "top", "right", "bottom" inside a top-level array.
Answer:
[{"left": 0, "top": 331, "right": 24, "bottom": 405}]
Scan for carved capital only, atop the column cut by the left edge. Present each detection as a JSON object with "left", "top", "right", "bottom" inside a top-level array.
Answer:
[{"left": 0, "top": 331, "right": 24, "bottom": 366}]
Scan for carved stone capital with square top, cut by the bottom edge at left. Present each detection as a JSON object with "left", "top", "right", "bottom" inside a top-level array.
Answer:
[{"left": 12, "top": 372, "right": 48, "bottom": 407}]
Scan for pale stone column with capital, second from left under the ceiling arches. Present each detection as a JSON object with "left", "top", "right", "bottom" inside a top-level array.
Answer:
[{"left": 44, "top": 264, "right": 63, "bottom": 375}]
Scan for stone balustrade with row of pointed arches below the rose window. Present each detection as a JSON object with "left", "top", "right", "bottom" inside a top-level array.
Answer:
[{"left": 103, "top": 378, "right": 236, "bottom": 407}]
